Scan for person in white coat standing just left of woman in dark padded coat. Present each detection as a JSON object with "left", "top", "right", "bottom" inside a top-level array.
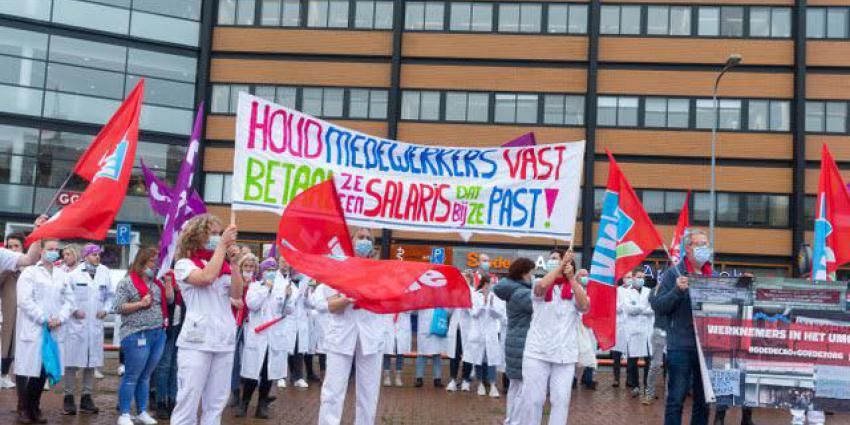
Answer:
[{"left": 464, "top": 276, "right": 507, "bottom": 398}]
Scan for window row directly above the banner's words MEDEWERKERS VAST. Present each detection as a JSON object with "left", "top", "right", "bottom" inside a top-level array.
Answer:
[{"left": 401, "top": 90, "right": 584, "bottom": 126}]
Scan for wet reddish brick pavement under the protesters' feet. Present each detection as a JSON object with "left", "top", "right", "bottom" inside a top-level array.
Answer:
[{"left": 0, "top": 359, "right": 850, "bottom": 425}]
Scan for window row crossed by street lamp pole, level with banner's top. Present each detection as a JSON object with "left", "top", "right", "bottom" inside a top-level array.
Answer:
[{"left": 596, "top": 96, "right": 791, "bottom": 131}]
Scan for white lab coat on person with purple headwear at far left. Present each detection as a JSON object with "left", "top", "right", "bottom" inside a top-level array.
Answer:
[{"left": 64, "top": 263, "right": 112, "bottom": 368}]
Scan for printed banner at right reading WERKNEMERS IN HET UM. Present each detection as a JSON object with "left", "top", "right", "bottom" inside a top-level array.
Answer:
[{"left": 689, "top": 277, "right": 850, "bottom": 412}]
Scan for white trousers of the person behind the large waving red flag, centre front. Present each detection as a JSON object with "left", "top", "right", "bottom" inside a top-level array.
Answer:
[{"left": 319, "top": 340, "right": 383, "bottom": 425}]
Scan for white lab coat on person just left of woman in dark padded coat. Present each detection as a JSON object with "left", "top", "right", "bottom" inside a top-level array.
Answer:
[{"left": 463, "top": 291, "right": 507, "bottom": 366}]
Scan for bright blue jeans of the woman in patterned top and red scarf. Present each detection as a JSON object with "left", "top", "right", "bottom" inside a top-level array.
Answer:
[{"left": 118, "top": 329, "right": 165, "bottom": 415}]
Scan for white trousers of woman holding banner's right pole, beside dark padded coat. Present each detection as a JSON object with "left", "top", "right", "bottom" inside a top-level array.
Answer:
[{"left": 521, "top": 357, "right": 576, "bottom": 425}]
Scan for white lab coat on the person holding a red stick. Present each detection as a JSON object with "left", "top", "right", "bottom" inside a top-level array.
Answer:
[{"left": 241, "top": 281, "right": 295, "bottom": 380}]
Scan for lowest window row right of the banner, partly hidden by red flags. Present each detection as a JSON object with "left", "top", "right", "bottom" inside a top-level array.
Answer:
[{"left": 594, "top": 189, "right": 788, "bottom": 228}]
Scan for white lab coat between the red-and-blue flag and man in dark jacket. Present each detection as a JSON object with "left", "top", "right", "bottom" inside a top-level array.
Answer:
[{"left": 617, "top": 287, "right": 654, "bottom": 358}]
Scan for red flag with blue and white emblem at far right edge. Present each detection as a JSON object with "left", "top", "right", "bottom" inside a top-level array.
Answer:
[{"left": 812, "top": 144, "right": 850, "bottom": 280}]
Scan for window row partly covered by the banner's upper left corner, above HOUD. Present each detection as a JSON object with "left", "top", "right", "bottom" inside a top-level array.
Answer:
[{"left": 210, "top": 84, "right": 389, "bottom": 120}]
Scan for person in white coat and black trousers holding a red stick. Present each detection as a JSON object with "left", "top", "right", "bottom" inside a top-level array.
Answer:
[{"left": 236, "top": 255, "right": 295, "bottom": 419}]
